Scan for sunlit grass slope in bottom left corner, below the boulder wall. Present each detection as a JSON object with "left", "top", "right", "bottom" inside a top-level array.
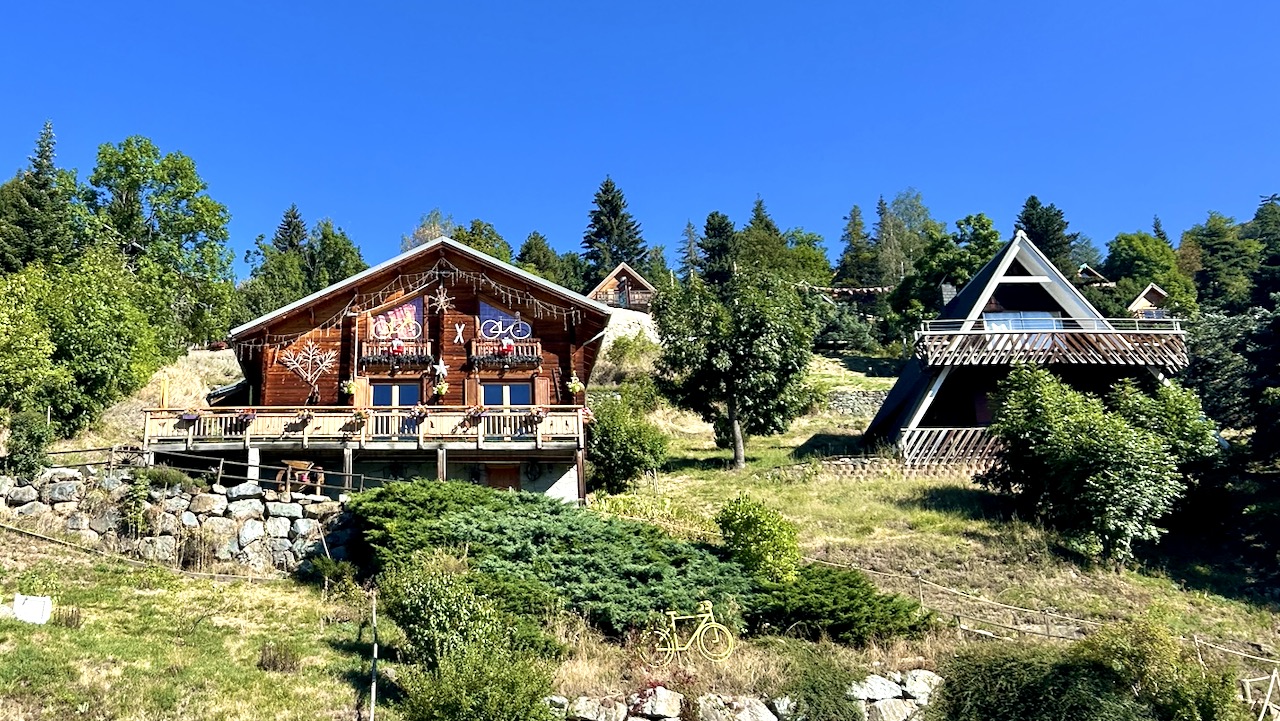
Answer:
[{"left": 0, "top": 531, "right": 367, "bottom": 721}]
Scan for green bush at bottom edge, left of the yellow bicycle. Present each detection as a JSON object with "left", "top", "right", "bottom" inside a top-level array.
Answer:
[{"left": 398, "top": 645, "right": 552, "bottom": 721}]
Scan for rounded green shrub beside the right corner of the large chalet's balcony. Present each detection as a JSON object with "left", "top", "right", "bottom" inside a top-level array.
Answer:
[{"left": 586, "top": 400, "right": 667, "bottom": 493}]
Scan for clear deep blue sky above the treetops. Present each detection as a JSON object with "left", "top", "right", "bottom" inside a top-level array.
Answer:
[{"left": 0, "top": 0, "right": 1280, "bottom": 274}]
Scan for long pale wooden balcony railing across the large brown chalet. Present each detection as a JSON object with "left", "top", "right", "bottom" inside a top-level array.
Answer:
[{"left": 143, "top": 406, "right": 584, "bottom": 448}]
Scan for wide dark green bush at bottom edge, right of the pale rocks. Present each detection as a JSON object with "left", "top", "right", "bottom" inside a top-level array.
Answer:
[{"left": 929, "top": 621, "right": 1248, "bottom": 721}]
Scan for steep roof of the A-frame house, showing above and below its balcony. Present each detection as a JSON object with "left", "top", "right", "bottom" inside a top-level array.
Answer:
[{"left": 867, "top": 231, "right": 1105, "bottom": 441}]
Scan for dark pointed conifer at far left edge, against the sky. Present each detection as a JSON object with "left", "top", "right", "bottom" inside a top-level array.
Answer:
[{"left": 0, "top": 122, "right": 78, "bottom": 273}]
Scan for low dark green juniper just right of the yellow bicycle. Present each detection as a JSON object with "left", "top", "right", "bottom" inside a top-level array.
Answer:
[{"left": 746, "top": 563, "right": 932, "bottom": 647}]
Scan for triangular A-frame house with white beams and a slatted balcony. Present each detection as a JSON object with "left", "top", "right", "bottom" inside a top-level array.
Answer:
[{"left": 867, "top": 231, "right": 1188, "bottom": 466}]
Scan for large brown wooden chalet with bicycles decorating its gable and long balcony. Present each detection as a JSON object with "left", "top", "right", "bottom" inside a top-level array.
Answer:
[{"left": 145, "top": 238, "right": 609, "bottom": 501}]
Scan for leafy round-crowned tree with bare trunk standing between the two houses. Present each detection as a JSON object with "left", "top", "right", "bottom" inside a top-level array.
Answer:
[{"left": 653, "top": 269, "right": 817, "bottom": 469}]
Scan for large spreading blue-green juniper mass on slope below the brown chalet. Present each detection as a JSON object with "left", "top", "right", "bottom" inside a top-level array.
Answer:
[{"left": 351, "top": 480, "right": 751, "bottom": 635}]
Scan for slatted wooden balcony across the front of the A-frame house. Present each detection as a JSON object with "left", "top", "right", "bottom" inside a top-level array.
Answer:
[{"left": 915, "top": 318, "right": 1188, "bottom": 371}]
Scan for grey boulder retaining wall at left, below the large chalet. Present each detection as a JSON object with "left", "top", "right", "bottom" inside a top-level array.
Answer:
[{"left": 0, "top": 467, "right": 351, "bottom": 571}]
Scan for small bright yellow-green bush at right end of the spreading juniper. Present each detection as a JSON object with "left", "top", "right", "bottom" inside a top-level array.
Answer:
[{"left": 716, "top": 494, "right": 800, "bottom": 583}]
